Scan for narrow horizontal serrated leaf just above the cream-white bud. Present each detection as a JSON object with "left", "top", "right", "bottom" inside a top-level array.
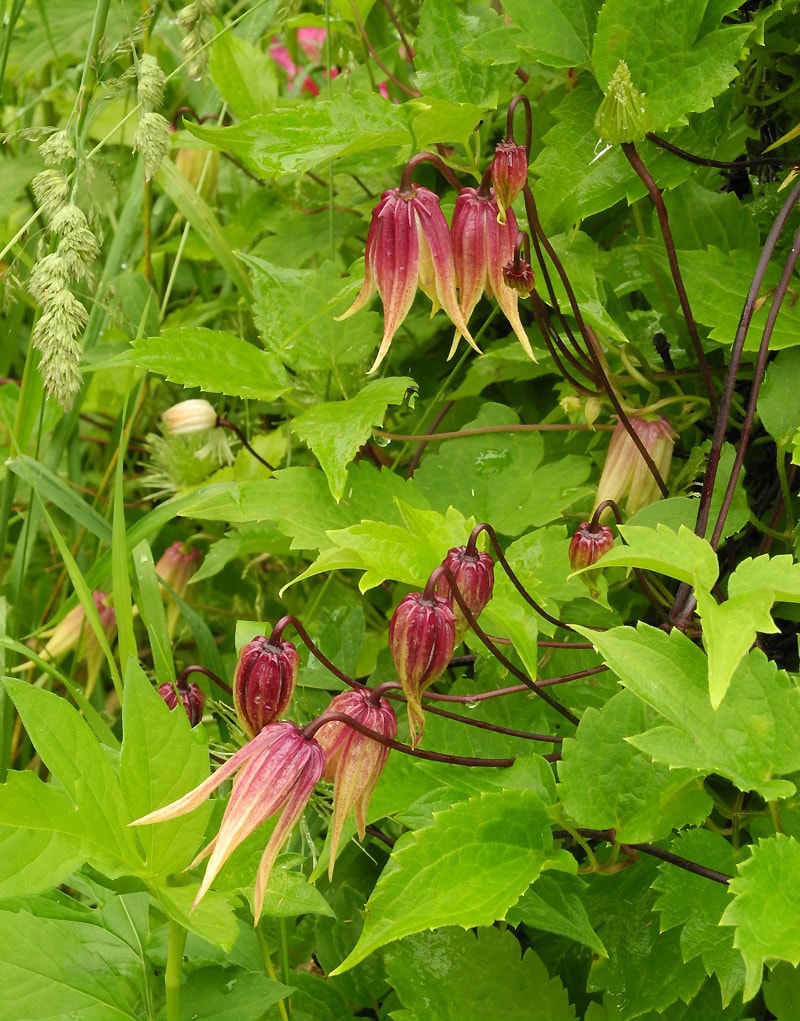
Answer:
[{"left": 133, "top": 326, "right": 291, "bottom": 401}]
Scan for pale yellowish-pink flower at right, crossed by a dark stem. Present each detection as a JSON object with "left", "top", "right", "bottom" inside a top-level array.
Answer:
[{"left": 595, "top": 416, "right": 678, "bottom": 515}]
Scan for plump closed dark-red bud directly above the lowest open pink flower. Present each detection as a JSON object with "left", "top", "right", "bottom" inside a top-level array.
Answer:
[{"left": 234, "top": 635, "right": 300, "bottom": 737}]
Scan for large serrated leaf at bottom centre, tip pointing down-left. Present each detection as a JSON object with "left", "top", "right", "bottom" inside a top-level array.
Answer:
[{"left": 333, "top": 791, "right": 570, "bottom": 974}]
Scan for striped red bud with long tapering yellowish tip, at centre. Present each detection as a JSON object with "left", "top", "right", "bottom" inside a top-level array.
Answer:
[{"left": 389, "top": 592, "right": 455, "bottom": 747}]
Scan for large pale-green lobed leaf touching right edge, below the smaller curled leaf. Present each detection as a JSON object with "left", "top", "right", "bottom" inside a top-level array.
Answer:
[{"left": 577, "top": 624, "right": 800, "bottom": 800}]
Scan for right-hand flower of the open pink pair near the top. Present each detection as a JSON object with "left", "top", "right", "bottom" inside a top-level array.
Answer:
[{"left": 450, "top": 187, "right": 536, "bottom": 361}]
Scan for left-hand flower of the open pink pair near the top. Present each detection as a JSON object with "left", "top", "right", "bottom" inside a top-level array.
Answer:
[{"left": 337, "top": 185, "right": 477, "bottom": 373}]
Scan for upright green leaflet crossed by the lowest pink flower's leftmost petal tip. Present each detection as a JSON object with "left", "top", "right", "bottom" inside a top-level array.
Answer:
[{"left": 119, "top": 660, "right": 212, "bottom": 876}]
